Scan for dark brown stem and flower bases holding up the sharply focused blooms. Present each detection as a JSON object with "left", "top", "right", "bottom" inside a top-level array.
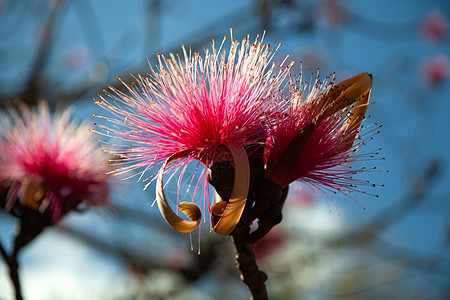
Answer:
[{"left": 207, "top": 157, "right": 288, "bottom": 300}]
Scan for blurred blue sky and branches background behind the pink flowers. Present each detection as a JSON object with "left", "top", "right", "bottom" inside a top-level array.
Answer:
[{"left": 0, "top": 0, "right": 450, "bottom": 300}]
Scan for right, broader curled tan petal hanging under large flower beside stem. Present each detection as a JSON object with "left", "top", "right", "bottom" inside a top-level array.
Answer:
[{"left": 211, "top": 145, "right": 250, "bottom": 235}]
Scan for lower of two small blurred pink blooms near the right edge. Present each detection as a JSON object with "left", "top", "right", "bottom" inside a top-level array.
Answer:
[{"left": 420, "top": 54, "right": 450, "bottom": 85}]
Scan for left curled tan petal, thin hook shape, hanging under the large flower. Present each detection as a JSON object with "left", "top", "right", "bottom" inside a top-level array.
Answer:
[{"left": 156, "top": 150, "right": 202, "bottom": 232}]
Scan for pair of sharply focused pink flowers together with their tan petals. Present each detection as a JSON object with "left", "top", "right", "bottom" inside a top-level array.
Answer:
[{"left": 95, "top": 31, "right": 380, "bottom": 234}]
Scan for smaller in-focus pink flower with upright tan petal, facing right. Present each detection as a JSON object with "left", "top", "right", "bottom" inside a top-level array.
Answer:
[{"left": 265, "top": 73, "right": 377, "bottom": 193}]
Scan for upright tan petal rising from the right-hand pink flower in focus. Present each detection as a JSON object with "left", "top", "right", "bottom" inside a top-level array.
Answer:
[{"left": 321, "top": 73, "right": 372, "bottom": 118}]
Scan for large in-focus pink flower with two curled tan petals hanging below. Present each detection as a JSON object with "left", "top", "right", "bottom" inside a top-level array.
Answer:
[{"left": 96, "top": 31, "right": 292, "bottom": 234}]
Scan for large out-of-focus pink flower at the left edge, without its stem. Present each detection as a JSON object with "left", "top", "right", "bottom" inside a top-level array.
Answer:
[{"left": 0, "top": 102, "right": 108, "bottom": 221}]
